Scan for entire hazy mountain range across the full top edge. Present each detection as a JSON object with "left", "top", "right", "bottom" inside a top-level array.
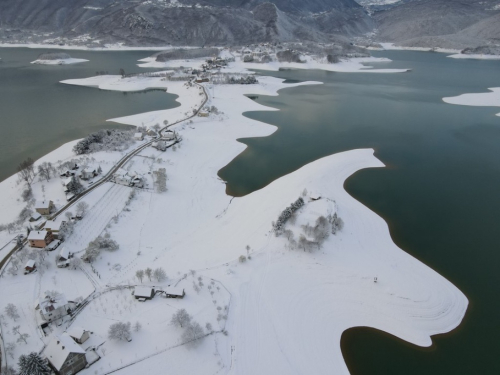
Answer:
[{"left": 0, "top": 0, "right": 500, "bottom": 48}]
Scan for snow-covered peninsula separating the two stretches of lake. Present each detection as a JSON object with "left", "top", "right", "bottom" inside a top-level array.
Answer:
[{"left": 0, "top": 56, "right": 468, "bottom": 375}]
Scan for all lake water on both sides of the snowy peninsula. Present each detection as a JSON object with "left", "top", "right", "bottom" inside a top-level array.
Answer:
[{"left": 0, "top": 48, "right": 500, "bottom": 375}]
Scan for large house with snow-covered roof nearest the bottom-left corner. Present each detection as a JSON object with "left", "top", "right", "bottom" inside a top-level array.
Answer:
[{"left": 43, "top": 333, "right": 87, "bottom": 375}]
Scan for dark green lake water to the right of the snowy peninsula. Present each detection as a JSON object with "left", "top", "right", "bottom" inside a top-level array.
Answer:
[{"left": 219, "top": 51, "right": 500, "bottom": 375}]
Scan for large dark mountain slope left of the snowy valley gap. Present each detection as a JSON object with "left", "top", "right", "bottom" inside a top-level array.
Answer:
[{"left": 0, "top": 0, "right": 373, "bottom": 45}]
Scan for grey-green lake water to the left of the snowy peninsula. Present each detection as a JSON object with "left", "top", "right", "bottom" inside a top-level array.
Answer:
[{"left": 0, "top": 48, "right": 179, "bottom": 181}]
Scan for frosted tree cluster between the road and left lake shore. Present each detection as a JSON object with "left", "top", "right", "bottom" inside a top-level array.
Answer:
[{"left": 73, "top": 129, "right": 134, "bottom": 155}]
